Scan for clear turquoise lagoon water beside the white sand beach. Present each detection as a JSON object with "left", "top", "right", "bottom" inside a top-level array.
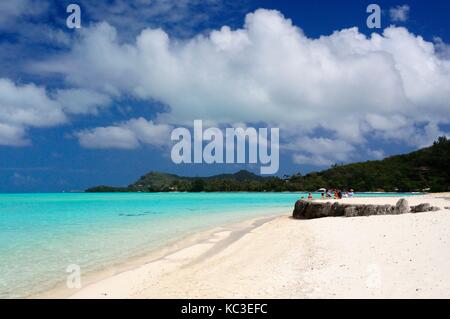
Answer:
[{"left": 0, "top": 193, "right": 420, "bottom": 298}]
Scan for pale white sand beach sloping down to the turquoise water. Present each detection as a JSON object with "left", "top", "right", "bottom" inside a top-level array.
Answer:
[{"left": 67, "top": 194, "right": 450, "bottom": 298}]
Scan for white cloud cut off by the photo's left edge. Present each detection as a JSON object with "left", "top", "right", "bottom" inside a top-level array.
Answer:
[{"left": 0, "top": 79, "right": 67, "bottom": 146}]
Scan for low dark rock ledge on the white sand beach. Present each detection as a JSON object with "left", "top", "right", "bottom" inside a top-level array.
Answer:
[{"left": 292, "top": 198, "right": 439, "bottom": 219}]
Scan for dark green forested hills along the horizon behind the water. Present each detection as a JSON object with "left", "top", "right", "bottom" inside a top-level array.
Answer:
[{"left": 86, "top": 137, "right": 450, "bottom": 192}]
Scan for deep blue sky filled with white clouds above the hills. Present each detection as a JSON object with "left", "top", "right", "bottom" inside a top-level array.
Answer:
[{"left": 0, "top": 0, "right": 450, "bottom": 192}]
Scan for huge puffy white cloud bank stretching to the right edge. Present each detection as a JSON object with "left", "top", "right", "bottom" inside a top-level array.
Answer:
[{"left": 29, "top": 9, "right": 450, "bottom": 163}]
